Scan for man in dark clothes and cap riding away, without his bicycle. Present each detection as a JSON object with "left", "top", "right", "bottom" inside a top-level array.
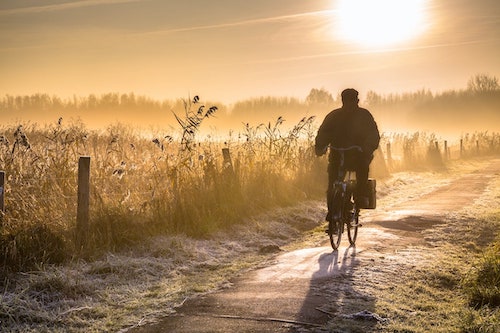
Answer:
[{"left": 315, "top": 88, "right": 380, "bottom": 221}]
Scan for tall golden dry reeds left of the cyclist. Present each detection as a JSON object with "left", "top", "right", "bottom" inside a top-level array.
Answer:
[{"left": 0, "top": 98, "right": 325, "bottom": 270}]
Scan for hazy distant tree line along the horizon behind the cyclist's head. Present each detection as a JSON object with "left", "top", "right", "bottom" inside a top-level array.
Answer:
[{"left": 0, "top": 74, "right": 500, "bottom": 134}]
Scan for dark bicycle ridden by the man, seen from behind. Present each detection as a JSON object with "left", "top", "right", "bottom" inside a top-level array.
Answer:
[{"left": 327, "top": 146, "right": 362, "bottom": 251}]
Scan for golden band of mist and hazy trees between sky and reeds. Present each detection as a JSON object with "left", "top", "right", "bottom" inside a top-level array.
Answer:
[{"left": 0, "top": 74, "right": 500, "bottom": 139}]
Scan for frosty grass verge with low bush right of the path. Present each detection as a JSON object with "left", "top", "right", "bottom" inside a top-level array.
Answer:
[{"left": 367, "top": 171, "right": 500, "bottom": 333}]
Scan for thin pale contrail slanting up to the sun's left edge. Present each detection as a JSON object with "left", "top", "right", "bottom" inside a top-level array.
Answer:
[{"left": 138, "top": 10, "right": 335, "bottom": 35}]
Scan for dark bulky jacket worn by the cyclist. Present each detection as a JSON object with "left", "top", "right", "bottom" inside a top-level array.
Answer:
[{"left": 315, "top": 106, "right": 380, "bottom": 157}]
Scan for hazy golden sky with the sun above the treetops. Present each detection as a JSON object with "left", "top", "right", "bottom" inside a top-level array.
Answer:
[{"left": 0, "top": 0, "right": 500, "bottom": 103}]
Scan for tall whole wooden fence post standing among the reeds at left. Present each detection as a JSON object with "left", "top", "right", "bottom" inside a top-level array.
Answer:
[{"left": 76, "top": 156, "right": 90, "bottom": 250}]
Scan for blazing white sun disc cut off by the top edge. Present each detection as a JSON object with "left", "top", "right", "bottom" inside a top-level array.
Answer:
[{"left": 336, "top": 0, "right": 427, "bottom": 46}]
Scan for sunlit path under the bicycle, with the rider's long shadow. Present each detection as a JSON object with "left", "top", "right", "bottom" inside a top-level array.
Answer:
[{"left": 129, "top": 160, "right": 500, "bottom": 333}]
